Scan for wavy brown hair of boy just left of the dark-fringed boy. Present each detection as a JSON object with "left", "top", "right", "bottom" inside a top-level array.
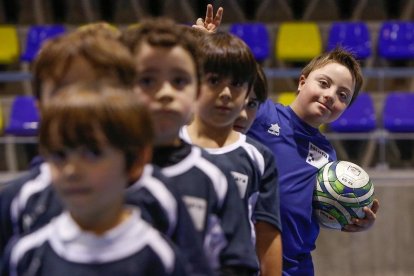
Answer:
[{"left": 121, "top": 18, "right": 202, "bottom": 94}]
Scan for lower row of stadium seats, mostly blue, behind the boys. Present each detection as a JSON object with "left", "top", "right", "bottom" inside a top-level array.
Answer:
[{"left": 0, "top": 91, "right": 414, "bottom": 170}]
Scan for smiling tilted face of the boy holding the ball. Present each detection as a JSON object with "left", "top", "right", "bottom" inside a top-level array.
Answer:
[{"left": 292, "top": 63, "right": 355, "bottom": 127}]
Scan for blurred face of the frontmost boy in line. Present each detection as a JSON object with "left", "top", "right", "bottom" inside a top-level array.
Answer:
[{"left": 45, "top": 140, "right": 128, "bottom": 220}]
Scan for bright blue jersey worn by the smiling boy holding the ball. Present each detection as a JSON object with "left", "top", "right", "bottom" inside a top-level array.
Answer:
[{"left": 248, "top": 100, "right": 336, "bottom": 275}]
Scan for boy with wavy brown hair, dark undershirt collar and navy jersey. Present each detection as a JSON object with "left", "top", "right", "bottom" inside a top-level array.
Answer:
[{"left": 123, "top": 19, "right": 256, "bottom": 275}]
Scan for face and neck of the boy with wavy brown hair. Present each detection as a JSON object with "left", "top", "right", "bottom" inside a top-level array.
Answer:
[{"left": 135, "top": 43, "right": 197, "bottom": 145}]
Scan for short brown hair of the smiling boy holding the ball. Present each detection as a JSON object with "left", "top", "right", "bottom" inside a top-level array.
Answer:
[{"left": 302, "top": 47, "right": 364, "bottom": 105}]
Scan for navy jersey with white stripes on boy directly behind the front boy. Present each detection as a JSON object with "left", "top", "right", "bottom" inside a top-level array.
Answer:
[{"left": 0, "top": 163, "right": 210, "bottom": 275}]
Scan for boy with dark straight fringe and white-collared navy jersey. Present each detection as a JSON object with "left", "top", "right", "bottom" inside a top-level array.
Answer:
[{"left": 181, "top": 32, "right": 281, "bottom": 275}]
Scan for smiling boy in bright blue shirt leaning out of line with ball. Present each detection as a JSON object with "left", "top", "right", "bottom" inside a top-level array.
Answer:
[{"left": 248, "top": 48, "right": 379, "bottom": 275}]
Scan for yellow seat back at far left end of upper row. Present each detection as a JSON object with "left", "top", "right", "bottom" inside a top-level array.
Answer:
[{"left": 0, "top": 25, "right": 20, "bottom": 64}]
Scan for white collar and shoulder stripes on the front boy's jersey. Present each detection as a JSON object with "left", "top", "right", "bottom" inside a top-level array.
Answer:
[{"left": 11, "top": 207, "right": 175, "bottom": 271}]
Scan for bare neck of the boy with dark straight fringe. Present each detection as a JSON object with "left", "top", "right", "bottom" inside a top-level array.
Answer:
[{"left": 187, "top": 118, "right": 240, "bottom": 148}]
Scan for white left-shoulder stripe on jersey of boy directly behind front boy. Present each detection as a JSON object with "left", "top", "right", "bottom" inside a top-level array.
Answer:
[{"left": 10, "top": 162, "right": 52, "bottom": 227}]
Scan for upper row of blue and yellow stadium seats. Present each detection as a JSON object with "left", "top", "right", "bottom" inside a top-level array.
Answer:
[{"left": 4, "top": 21, "right": 414, "bottom": 71}]
